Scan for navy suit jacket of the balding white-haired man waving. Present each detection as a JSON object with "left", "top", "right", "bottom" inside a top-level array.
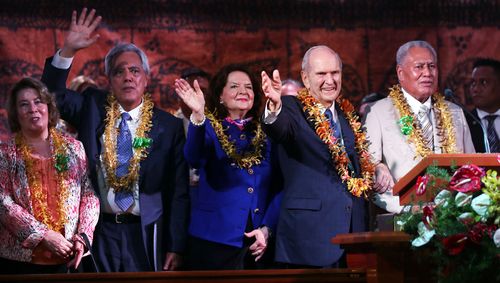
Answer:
[{"left": 264, "top": 96, "right": 367, "bottom": 266}]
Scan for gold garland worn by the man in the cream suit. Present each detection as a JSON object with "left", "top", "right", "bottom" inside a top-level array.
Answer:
[{"left": 389, "top": 85, "right": 457, "bottom": 158}]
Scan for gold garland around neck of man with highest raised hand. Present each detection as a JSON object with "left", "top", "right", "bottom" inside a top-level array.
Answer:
[{"left": 103, "top": 93, "right": 154, "bottom": 192}]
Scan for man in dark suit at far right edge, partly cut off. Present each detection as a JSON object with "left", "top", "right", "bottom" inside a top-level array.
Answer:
[{"left": 466, "top": 59, "right": 500, "bottom": 152}]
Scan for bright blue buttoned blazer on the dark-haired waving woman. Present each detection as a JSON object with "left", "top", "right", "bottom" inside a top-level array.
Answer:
[{"left": 184, "top": 119, "right": 281, "bottom": 247}]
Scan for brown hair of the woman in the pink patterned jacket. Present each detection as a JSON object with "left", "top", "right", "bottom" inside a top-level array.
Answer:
[{"left": 6, "top": 78, "right": 59, "bottom": 133}]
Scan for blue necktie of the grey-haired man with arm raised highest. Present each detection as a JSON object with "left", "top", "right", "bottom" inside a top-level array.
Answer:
[{"left": 115, "top": 112, "right": 134, "bottom": 211}]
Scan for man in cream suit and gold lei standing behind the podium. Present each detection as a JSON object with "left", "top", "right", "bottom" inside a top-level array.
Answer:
[{"left": 365, "top": 41, "right": 474, "bottom": 213}]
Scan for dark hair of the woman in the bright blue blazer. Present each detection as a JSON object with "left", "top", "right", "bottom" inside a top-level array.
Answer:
[{"left": 205, "top": 64, "right": 264, "bottom": 121}]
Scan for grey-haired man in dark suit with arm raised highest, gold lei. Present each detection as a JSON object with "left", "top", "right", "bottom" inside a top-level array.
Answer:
[{"left": 42, "top": 9, "right": 189, "bottom": 272}]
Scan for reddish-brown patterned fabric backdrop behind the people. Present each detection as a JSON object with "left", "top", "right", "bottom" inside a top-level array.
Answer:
[{"left": 0, "top": 0, "right": 500, "bottom": 139}]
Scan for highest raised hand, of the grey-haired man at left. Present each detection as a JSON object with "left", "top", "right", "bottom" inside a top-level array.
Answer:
[{"left": 60, "top": 8, "right": 102, "bottom": 58}]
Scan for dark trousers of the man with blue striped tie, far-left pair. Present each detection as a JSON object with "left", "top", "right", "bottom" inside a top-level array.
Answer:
[{"left": 92, "top": 219, "right": 153, "bottom": 272}]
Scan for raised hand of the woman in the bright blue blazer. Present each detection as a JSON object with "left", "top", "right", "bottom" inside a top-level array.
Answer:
[{"left": 174, "top": 79, "right": 205, "bottom": 121}]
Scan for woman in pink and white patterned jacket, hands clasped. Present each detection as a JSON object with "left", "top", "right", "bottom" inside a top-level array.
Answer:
[{"left": 0, "top": 78, "right": 99, "bottom": 274}]
